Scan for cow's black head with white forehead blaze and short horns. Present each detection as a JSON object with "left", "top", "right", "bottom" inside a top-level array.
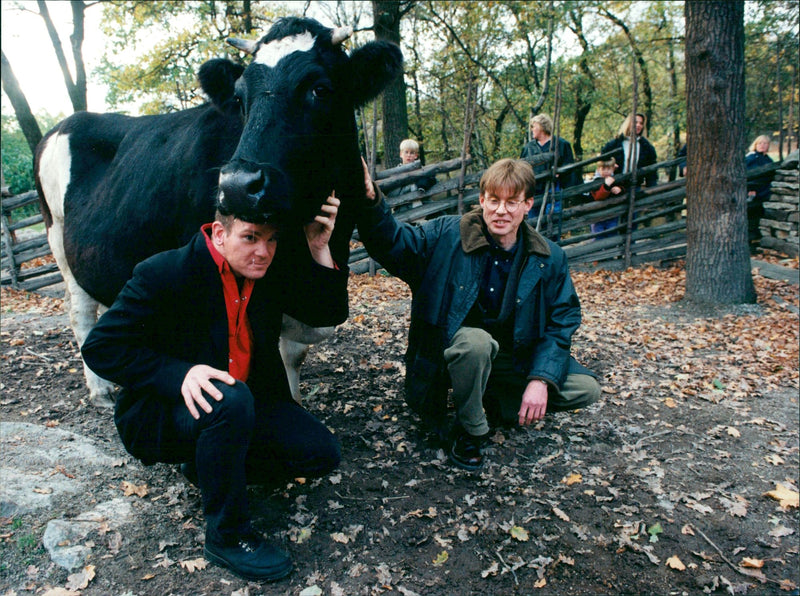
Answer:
[{"left": 200, "top": 17, "right": 402, "bottom": 227}]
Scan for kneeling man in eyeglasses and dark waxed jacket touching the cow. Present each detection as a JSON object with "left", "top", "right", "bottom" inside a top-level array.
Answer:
[{"left": 358, "top": 159, "right": 600, "bottom": 470}]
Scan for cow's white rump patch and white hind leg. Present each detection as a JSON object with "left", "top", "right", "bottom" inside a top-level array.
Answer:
[{"left": 39, "top": 134, "right": 114, "bottom": 407}]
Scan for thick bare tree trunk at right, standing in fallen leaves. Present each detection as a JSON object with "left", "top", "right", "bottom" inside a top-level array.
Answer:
[{"left": 685, "top": 0, "right": 756, "bottom": 304}]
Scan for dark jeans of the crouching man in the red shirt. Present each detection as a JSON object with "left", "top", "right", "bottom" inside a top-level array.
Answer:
[{"left": 169, "top": 381, "right": 341, "bottom": 544}]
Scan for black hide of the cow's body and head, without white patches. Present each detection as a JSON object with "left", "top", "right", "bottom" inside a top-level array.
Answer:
[{"left": 37, "top": 19, "right": 402, "bottom": 304}]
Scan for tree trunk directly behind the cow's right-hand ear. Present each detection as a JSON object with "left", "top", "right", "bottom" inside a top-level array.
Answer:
[{"left": 372, "top": 0, "right": 408, "bottom": 168}]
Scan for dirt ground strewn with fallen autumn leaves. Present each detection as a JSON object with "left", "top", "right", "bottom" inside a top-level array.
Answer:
[{"left": 0, "top": 262, "right": 800, "bottom": 596}]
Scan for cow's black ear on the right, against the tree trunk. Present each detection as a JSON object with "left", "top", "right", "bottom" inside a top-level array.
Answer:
[{"left": 348, "top": 41, "right": 403, "bottom": 106}]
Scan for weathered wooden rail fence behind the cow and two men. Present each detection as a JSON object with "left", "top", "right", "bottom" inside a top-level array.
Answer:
[{"left": 0, "top": 158, "right": 781, "bottom": 290}]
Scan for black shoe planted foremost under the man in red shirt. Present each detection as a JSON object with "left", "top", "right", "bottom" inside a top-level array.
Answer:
[{"left": 203, "top": 534, "right": 292, "bottom": 581}]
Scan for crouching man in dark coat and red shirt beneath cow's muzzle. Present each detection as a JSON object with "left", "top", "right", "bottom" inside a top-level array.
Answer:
[{"left": 82, "top": 193, "right": 347, "bottom": 581}]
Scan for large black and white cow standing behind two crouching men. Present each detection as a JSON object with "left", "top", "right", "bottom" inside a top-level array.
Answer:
[{"left": 35, "top": 17, "right": 402, "bottom": 404}]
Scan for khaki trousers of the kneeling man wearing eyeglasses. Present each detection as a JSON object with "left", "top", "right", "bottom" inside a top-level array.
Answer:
[{"left": 444, "top": 327, "right": 600, "bottom": 435}]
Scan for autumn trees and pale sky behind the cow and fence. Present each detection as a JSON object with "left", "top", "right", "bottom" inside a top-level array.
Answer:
[{"left": 2, "top": 0, "right": 800, "bottom": 193}]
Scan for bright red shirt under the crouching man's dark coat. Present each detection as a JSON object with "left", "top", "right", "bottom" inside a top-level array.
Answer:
[{"left": 200, "top": 224, "right": 255, "bottom": 382}]
